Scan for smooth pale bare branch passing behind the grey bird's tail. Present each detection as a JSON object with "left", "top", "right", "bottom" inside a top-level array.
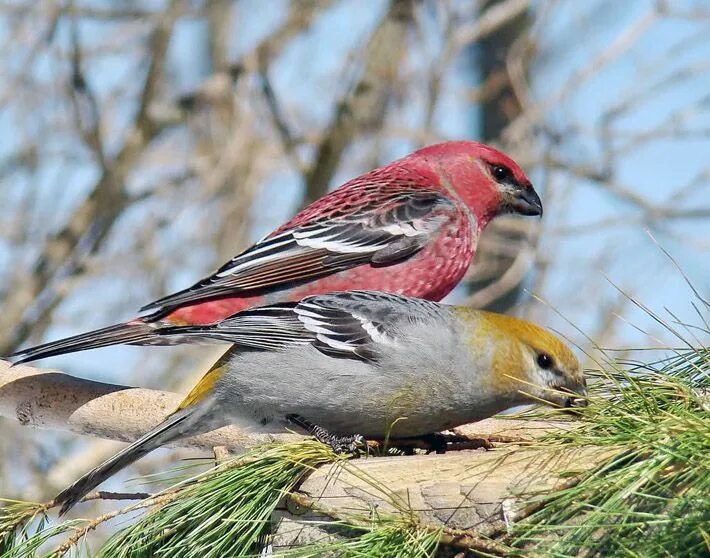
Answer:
[{"left": 0, "top": 361, "right": 300, "bottom": 450}]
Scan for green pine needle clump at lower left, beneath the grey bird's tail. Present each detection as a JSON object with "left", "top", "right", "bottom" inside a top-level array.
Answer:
[{"left": 99, "top": 441, "right": 338, "bottom": 558}]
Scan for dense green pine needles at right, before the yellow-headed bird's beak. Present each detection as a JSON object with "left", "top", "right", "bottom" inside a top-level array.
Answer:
[{"left": 510, "top": 348, "right": 710, "bottom": 558}]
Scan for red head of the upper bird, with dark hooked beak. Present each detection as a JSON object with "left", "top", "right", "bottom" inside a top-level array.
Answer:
[{"left": 405, "top": 141, "right": 542, "bottom": 229}]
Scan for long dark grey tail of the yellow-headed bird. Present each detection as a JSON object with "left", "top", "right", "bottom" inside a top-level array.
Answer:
[{"left": 54, "top": 406, "right": 204, "bottom": 515}]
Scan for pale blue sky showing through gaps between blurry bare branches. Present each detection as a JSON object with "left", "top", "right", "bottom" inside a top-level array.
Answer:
[{"left": 0, "top": 0, "right": 710, "bottom": 381}]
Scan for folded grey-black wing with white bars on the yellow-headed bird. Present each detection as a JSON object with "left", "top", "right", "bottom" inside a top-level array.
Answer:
[{"left": 165, "top": 291, "right": 447, "bottom": 362}]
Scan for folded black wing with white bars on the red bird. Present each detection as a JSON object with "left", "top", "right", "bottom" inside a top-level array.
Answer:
[{"left": 142, "top": 190, "right": 455, "bottom": 311}]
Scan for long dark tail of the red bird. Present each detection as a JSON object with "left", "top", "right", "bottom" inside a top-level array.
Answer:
[{"left": 10, "top": 320, "right": 160, "bottom": 364}]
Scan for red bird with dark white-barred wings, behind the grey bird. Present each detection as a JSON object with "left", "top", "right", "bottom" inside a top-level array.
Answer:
[{"left": 12, "top": 141, "right": 542, "bottom": 362}]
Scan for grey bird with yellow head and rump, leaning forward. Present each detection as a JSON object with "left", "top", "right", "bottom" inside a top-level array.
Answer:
[{"left": 55, "top": 291, "right": 586, "bottom": 513}]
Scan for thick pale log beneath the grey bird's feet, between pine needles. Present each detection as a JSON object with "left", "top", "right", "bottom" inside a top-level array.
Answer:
[{"left": 273, "top": 442, "right": 615, "bottom": 556}]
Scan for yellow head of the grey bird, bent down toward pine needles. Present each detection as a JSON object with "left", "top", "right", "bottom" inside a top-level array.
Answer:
[{"left": 459, "top": 308, "right": 587, "bottom": 407}]
